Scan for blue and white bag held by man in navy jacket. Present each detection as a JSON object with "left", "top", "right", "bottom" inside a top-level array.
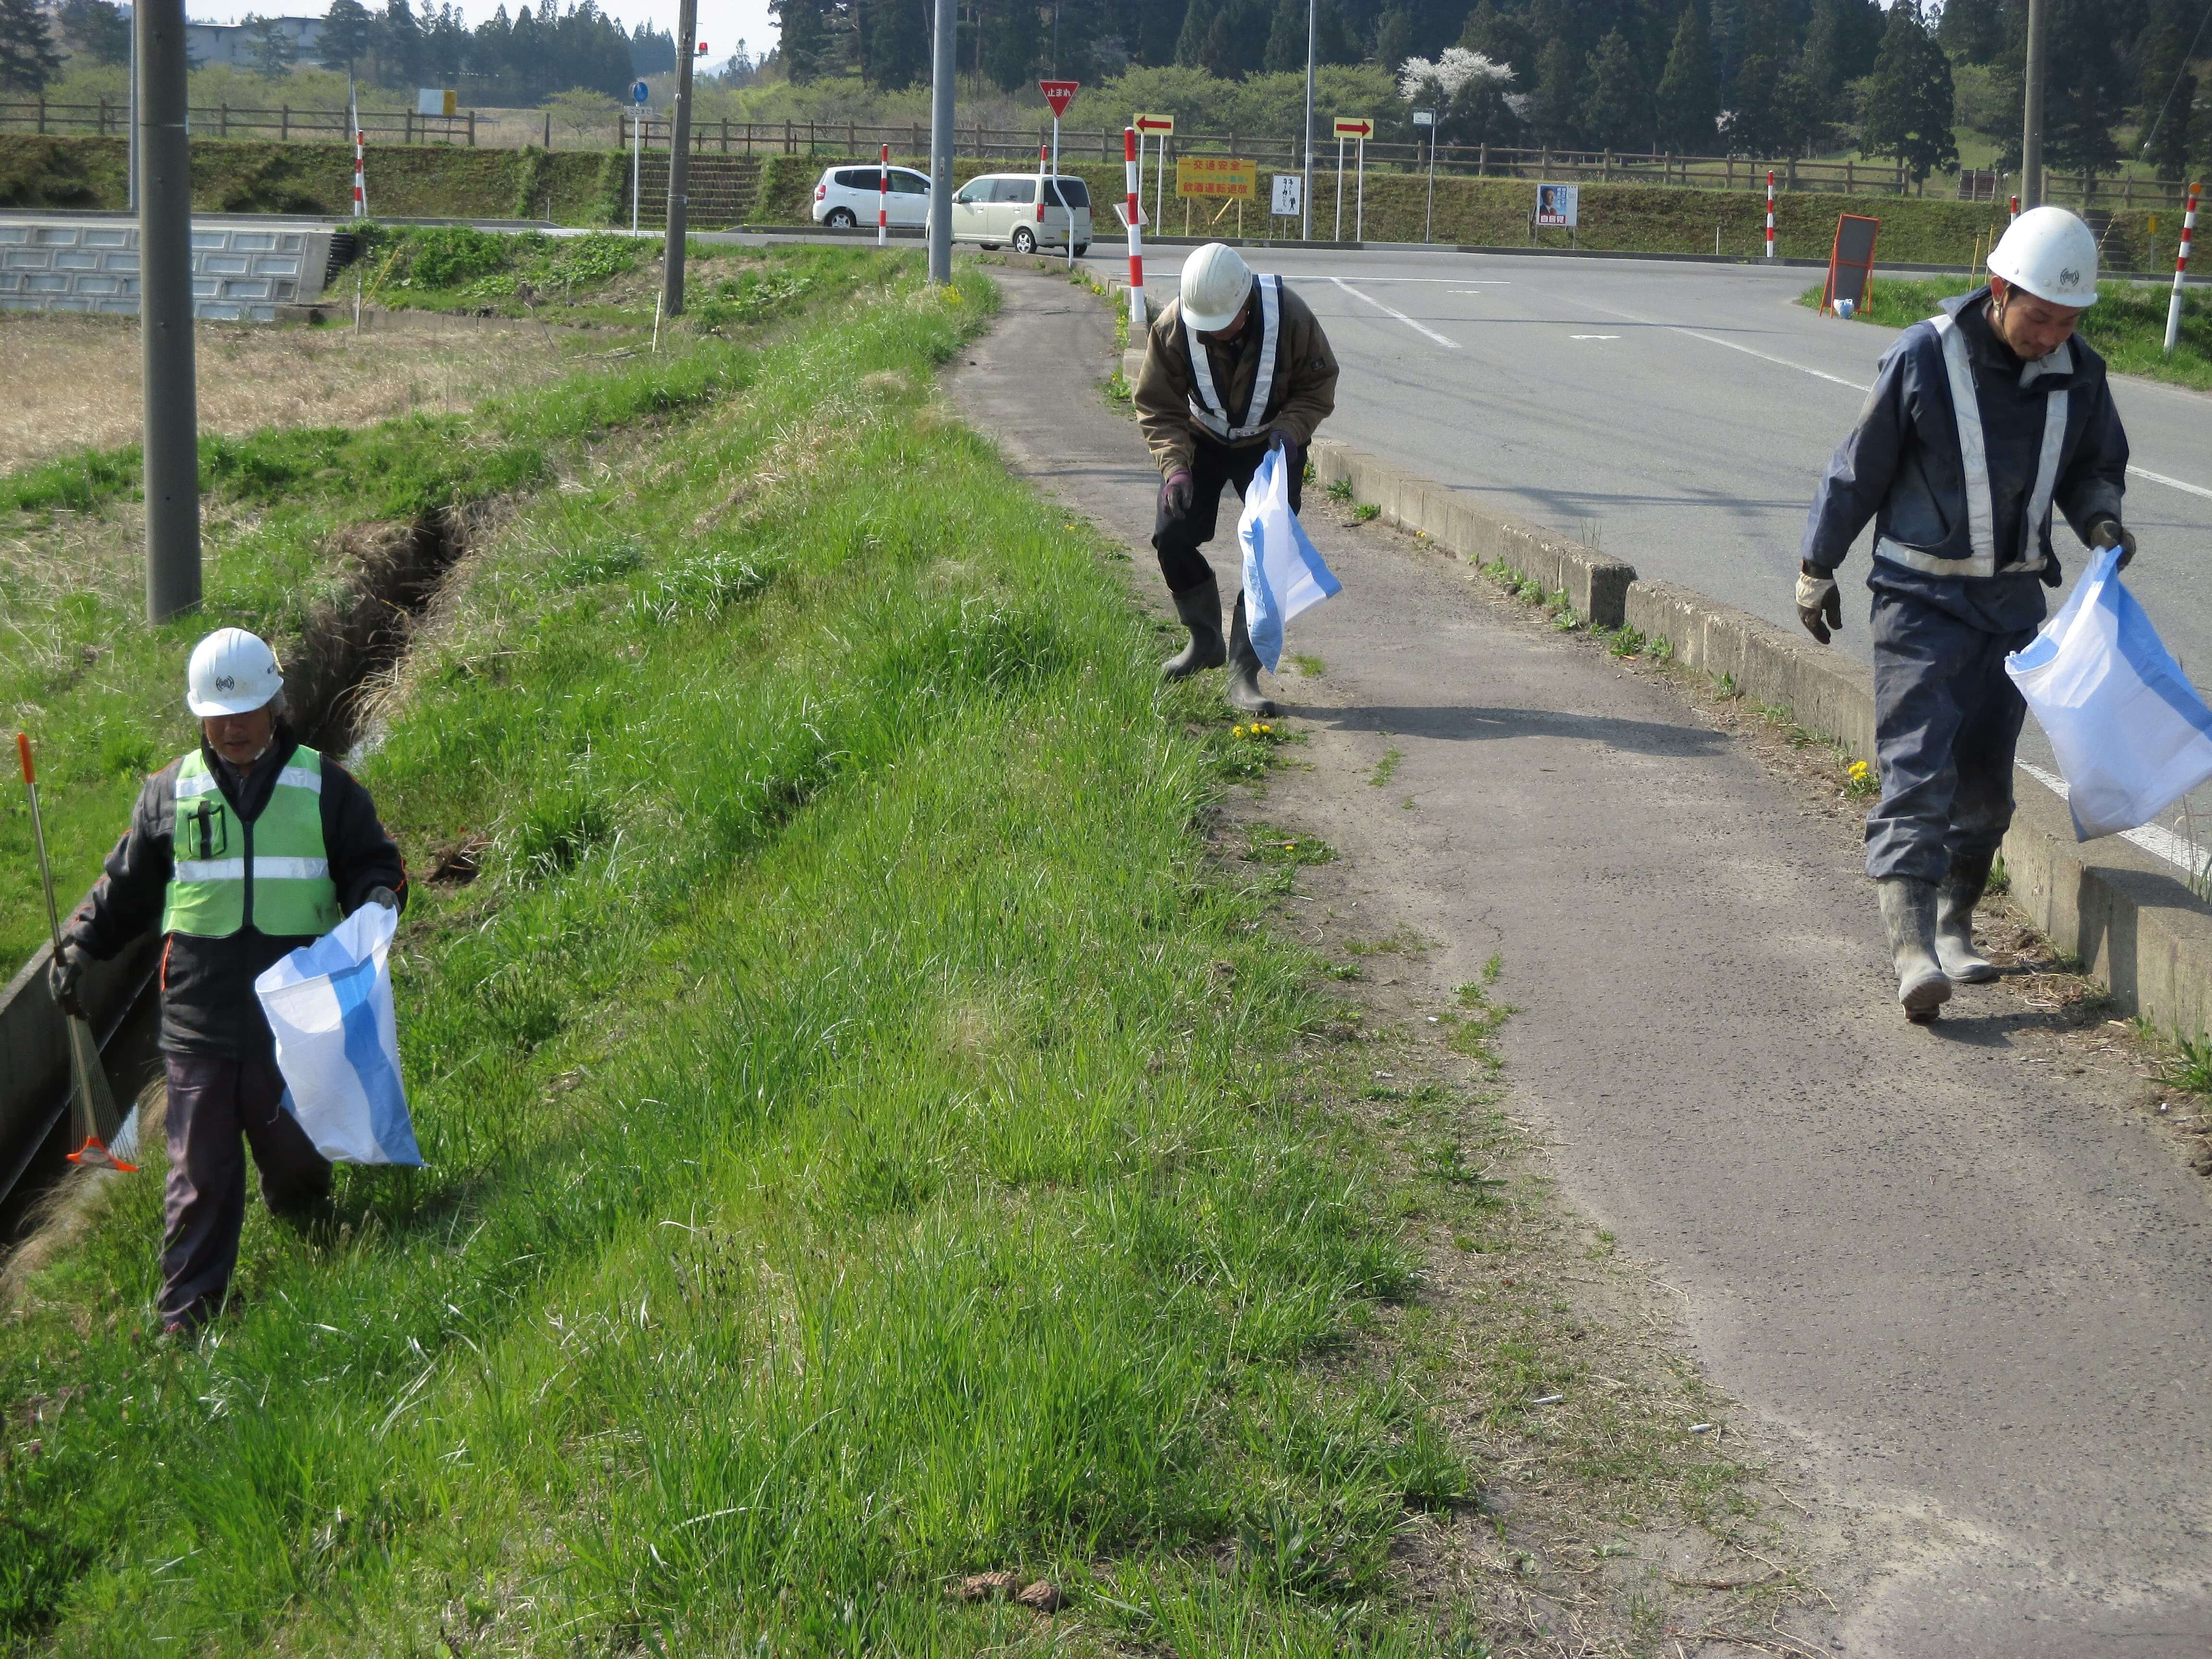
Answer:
[{"left": 2004, "top": 546, "right": 2212, "bottom": 841}]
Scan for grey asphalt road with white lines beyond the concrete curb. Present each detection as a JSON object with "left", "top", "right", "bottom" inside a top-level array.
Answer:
[{"left": 1123, "top": 250, "right": 2212, "bottom": 679}]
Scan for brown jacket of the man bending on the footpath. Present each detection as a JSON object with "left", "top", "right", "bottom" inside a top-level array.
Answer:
[{"left": 1135, "top": 283, "right": 1336, "bottom": 478}]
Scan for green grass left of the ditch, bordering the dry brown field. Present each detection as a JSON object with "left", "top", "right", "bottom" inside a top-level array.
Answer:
[{"left": 0, "top": 230, "right": 872, "bottom": 971}]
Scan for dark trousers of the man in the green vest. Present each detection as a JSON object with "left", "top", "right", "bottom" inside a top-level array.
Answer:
[{"left": 161, "top": 1055, "right": 330, "bottom": 1325}]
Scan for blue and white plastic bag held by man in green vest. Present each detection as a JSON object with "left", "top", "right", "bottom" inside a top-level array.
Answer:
[{"left": 254, "top": 905, "right": 422, "bottom": 1164}]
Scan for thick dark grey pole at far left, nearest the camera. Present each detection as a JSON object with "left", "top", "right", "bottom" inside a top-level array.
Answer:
[{"left": 131, "top": 0, "right": 199, "bottom": 624}]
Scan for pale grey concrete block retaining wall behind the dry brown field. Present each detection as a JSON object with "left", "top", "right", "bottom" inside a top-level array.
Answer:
[{"left": 0, "top": 217, "right": 332, "bottom": 323}]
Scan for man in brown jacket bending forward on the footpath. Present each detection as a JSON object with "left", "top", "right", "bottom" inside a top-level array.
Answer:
[{"left": 1135, "top": 241, "right": 1336, "bottom": 714}]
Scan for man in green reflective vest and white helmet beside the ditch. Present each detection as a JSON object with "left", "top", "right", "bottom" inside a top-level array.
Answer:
[{"left": 51, "top": 628, "right": 407, "bottom": 1336}]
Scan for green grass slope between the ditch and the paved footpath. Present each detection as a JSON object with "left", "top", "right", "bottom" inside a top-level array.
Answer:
[{"left": 0, "top": 259, "right": 1467, "bottom": 1659}]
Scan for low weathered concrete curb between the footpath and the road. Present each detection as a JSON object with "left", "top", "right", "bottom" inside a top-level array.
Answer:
[{"left": 1314, "top": 440, "right": 2212, "bottom": 1037}]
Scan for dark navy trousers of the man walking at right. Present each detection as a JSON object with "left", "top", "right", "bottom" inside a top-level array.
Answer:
[{"left": 1867, "top": 589, "right": 2035, "bottom": 880}]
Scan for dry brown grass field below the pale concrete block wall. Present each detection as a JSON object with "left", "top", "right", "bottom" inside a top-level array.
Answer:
[{"left": 0, "top": 312, "right": 597, "bottom": 471}]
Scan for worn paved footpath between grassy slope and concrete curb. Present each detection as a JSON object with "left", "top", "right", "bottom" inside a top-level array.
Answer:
[{"left": 953, "top": 272, "right": 2212, "bottom": 1659}]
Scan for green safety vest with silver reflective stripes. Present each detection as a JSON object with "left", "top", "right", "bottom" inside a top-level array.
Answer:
[{"left": 161, "top": 745, "right": 338, "bottom": 938}]
